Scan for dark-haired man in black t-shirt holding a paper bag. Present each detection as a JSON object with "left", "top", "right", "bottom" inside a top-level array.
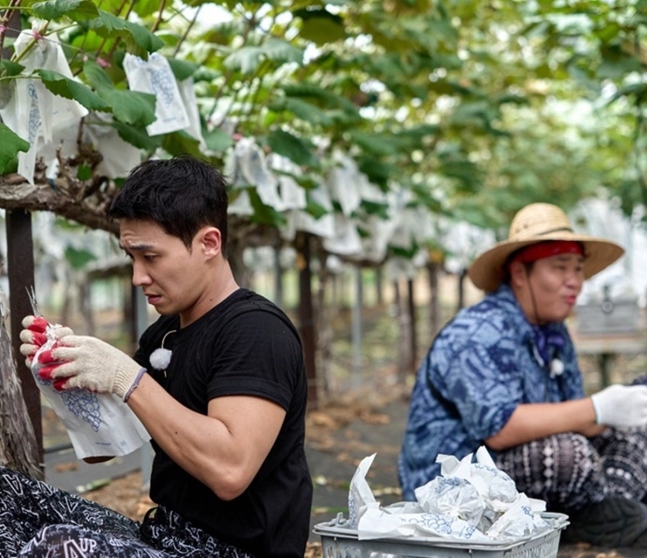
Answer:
[{"left": 16, "top": 157, "right": 312, "bottom": 557}]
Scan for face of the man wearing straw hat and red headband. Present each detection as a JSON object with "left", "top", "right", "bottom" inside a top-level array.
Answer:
[{"left": 513, "top": 254, "right": 584, "bottom": 323}]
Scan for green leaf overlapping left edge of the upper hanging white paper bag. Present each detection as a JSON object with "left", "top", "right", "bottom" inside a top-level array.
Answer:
[{"left": 83, "top": 61, "right": 156, "bottom": 126}]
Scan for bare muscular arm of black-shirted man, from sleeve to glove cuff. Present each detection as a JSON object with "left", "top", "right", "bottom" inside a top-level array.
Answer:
[{"left": 128, "top": 374, "right": 286, "bottom": 500}]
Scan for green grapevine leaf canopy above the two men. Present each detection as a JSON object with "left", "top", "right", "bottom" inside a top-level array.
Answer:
[{"left": 0, "top": 0, "right": 647, "bottom": 247}]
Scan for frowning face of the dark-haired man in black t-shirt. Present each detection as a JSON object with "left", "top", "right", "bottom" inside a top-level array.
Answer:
[{"left": 119, "top": 219, "right": 208, "bottom": 325}]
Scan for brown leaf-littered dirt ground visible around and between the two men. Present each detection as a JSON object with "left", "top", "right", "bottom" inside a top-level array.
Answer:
[{"left": 43, "top": 302, "right": 647, "bottom": 558}]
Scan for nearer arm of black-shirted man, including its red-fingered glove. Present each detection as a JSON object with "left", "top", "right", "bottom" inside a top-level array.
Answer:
[{"left": 31, "top": 335, "right": 286, "bottom": 500}]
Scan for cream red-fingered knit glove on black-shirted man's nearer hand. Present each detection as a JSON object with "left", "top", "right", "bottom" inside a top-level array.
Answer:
[{"left": 38, "top": 335, "right": 146, "bottom": 401}]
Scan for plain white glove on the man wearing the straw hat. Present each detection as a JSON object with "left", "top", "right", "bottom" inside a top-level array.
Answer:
[{"left": 591, "top": 384, "right": 647, "bottom": 428}]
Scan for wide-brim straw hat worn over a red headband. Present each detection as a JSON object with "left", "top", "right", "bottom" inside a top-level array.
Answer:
[{"left": 468, "top": 203, "right": 624, "bottom": 292}]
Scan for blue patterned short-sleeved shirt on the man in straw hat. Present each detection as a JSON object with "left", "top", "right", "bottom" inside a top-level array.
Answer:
[{"left": 398, "top": 284, "right": 585, "bottom": 500}]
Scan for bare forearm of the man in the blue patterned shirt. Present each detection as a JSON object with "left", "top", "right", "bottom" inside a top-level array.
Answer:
[{"left": 485, "top": 397, "right": 605, "bottom": 450}]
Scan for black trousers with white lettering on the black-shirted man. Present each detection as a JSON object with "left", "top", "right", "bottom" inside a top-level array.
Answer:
[{"left": 0, "top": 467, "right": 253, "bottom": 558}]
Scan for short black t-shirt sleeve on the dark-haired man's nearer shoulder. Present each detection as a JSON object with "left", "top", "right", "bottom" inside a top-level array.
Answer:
[{"left": 207, "top": 310, "right": 301, "bottom": 410}]
